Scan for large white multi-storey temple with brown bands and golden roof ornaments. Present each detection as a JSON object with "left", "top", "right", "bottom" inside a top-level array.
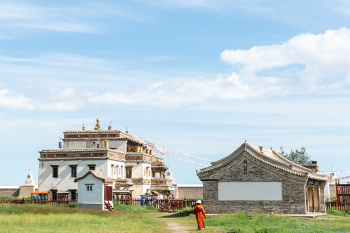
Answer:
[{"left": 38, "top": 119, "right": 173, "bottom": 199}]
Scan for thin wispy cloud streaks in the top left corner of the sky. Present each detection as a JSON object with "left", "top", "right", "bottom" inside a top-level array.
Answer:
[{"left": 0, "top": 1, "right": 144, "bottom": 35}]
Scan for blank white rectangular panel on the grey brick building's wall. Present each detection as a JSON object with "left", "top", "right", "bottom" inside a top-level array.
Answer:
[{"left": 218, "top": 182, "right": 282, "bottom": 201}]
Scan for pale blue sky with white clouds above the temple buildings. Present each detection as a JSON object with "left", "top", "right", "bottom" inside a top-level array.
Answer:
[{"left": 0, "top": 0, "right": 350, "bottom": 185}]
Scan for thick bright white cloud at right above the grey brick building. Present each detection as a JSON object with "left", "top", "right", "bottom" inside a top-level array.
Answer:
[{"left": 221, "top": 28, "right": 350, "bottom": 90}]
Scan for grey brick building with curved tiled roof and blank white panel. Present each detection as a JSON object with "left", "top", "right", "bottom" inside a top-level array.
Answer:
[{"left": 197, "top": 142, "right": 328, "bottom": 214}]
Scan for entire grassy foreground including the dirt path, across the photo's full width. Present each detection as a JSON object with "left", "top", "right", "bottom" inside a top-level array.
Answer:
[{"left": 0, "top": 204, "right": 350, "bottom": 232}]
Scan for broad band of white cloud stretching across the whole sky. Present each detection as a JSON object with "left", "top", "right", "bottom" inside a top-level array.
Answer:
[{"left": 0, "top": 28, "right": 350, "bottom": 111}]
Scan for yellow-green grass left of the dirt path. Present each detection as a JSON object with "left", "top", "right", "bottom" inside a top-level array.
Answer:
[{"left": 0, "top": 204, "right": 164, "bottom": 232}]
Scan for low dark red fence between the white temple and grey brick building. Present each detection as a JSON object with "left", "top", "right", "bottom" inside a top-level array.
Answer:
[{"left": 118, "top": 199, "right": 196, "bottom": 212}]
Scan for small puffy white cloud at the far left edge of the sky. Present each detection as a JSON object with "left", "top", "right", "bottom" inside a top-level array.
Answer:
[{"left": 0, "top": 89, "right": 36, "bottom": 110}]
